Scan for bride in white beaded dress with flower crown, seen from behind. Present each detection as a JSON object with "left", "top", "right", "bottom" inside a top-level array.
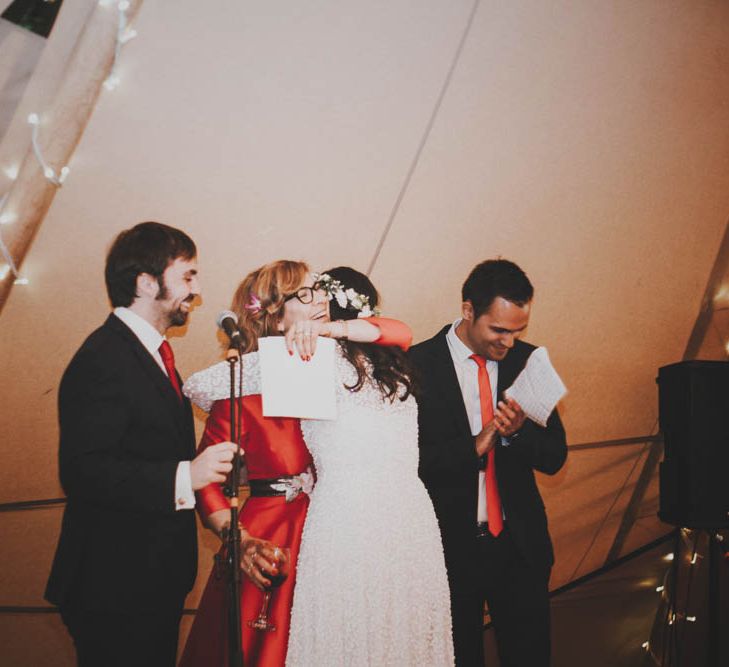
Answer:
[{"left": 286, "top": 267, "right": 453, "bottom": 667}]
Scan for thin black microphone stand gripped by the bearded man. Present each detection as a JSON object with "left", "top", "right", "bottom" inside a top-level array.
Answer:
[{"left": 222, "top": 346, "right": 243, "bottom": 667}]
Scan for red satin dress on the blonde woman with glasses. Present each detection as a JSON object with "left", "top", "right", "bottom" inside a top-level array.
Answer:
[{"left": 179, "top": 318, "right": 412, "bottom": 667}]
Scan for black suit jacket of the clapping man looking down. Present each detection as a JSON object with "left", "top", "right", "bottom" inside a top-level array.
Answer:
[{"left": 410, "top": 325, "right": 567, "bottom": 577}]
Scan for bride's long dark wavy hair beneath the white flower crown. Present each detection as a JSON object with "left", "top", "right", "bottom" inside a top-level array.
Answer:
[{"left": 325, "top": 266, "right": 419, "bottom": 402}]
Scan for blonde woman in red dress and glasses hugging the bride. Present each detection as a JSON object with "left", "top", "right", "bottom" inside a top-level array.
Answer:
[{"left": 180, "top": 260, "right": 412, "bottom": 667}]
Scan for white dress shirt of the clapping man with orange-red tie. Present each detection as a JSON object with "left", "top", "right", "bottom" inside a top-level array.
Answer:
[{"left": 446, "top": 318, "right": 506, "bottom": 521}]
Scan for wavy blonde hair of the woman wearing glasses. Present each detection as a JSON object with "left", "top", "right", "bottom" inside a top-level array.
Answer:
[{"left": 230, "top": 259, "right": 309, "bottom": 352}]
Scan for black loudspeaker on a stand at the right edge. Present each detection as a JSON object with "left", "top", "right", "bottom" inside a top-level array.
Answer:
[{"left": 657, "top": 361, "right": 729, "bottom": 529}]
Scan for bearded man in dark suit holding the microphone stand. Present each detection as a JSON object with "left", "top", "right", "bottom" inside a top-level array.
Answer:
[{"left": 46, "top": 222, "right": 235, "bottom": 667}]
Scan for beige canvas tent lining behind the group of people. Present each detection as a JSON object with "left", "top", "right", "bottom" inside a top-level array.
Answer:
[{"left": 0, "top": 0, "right": 729, "bottom": 664}]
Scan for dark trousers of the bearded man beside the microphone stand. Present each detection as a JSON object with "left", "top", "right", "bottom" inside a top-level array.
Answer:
[{"left": 61, "top": 607, "right": 182, "bottom": 667}]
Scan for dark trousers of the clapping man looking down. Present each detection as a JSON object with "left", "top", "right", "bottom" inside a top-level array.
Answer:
[{"left": 450, "top": 528, "right": 550, "bottom": 667}]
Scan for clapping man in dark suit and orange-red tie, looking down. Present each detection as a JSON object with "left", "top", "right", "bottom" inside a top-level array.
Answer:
[{"left": 411, "top": 260, "right": 567, "bottom": 667}]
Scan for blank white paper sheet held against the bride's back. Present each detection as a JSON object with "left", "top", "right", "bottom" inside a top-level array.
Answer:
[{"left": 258, "top": 336, "right": 337, "bottom": 419}]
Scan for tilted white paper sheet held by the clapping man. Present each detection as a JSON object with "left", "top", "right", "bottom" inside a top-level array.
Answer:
[{"left": 504, "top": 347, "right": 567, "bottom": 426}]
